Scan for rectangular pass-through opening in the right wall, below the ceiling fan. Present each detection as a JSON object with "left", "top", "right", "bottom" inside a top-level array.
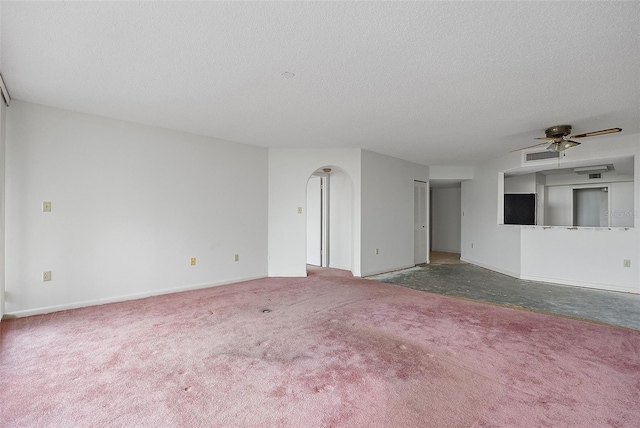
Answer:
[{"left": 503, "top": 156, "right": 635, "bottom": 227}]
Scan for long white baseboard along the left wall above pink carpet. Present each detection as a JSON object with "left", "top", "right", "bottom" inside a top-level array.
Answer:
[{"left": 5, "top": 275, "right": 265, "bottom": 318}]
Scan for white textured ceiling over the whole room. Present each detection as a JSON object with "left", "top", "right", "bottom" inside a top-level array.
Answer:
[{"left": 0, "top": 1, "right": 640, "bottom": 165}]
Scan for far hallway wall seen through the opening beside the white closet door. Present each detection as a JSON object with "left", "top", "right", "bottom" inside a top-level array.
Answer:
[{"left": 431, "top": 185, "right": 462, "bottom": 253}]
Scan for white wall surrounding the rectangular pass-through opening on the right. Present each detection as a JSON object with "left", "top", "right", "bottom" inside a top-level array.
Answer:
[{"left": 462, "top": 134, "right": 640, "bottom": 293}]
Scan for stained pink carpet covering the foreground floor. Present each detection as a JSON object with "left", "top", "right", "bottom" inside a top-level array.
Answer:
[{"left": 0, "top": 269, "right": 640, "bottom": 427}]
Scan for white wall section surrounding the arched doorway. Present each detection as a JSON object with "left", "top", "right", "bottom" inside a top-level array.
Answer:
[{"left": 269, "top": 149, "right": 361, "bottom": 277}]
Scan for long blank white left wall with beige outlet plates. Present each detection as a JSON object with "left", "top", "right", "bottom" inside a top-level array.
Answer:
[{"left": 6, "top": 101, "right": 268, "bottom": 315}]
